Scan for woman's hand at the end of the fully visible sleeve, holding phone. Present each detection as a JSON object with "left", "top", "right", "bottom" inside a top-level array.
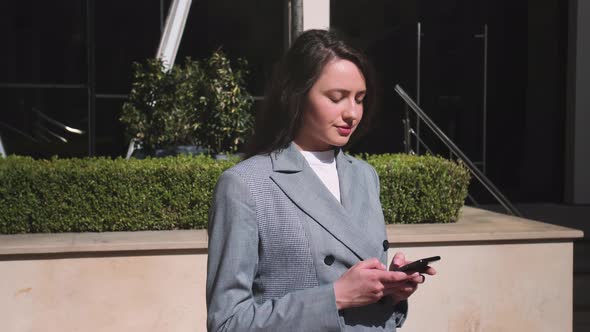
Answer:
[{"left": 334, "top": 258, "right": 418, "bottom": 310}]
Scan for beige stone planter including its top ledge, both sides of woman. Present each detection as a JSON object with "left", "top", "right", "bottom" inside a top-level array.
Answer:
[{"left": 0, "top": 207, "right": 583, "bottom": 332}]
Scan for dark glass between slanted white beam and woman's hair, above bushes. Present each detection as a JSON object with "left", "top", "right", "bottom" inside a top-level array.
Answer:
[{"left": 176, "top": 0, "right": 284, "bottom": 96}]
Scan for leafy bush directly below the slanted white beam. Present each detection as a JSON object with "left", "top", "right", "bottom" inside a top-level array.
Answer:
[{"left": 120, "top": 58, "right": 205, "bottom": 150}]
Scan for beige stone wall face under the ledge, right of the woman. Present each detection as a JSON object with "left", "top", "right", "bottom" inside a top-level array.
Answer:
[{"left": 390, "top": 243, "right": 573, "bottom": 332}]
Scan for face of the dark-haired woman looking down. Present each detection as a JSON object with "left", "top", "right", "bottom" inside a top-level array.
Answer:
[{"left": 295, "top": 59, "right": 367, "bottom": 151}]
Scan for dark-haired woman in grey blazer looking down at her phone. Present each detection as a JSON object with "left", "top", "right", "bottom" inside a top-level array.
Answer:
[{"left": 207, "top": 30, "right": 435, "bottom": 331}]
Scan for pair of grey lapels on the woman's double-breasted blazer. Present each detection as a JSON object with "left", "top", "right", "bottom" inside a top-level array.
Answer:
[{"left": 271, "top": 143, "right": 375, "bottom": 259}]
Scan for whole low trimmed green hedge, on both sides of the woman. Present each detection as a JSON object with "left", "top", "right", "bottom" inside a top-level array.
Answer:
[{"left": 0, "top": 155, "right": 469, "bottom": 234}]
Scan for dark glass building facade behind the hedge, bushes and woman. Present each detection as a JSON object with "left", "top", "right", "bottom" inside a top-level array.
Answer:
[{"left": 0, "top": 0, "right": 568, "bottom": 201}]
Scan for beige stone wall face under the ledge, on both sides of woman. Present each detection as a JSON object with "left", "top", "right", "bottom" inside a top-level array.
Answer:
[{"left": 0, "top": 243, "right": 572, "bottom": 332}]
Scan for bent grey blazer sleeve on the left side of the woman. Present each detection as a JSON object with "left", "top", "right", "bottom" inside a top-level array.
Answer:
[{"left": 207, "top": 170, "right": 340, "bottom": 332}]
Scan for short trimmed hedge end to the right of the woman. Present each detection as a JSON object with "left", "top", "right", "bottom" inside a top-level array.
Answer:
[{"left": 365, "top": 154, "right": 471, "bottom": 224}]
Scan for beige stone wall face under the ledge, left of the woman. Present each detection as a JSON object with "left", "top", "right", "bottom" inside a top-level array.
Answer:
[{"left": 0, "top": 254, "right": 207, "bottom": 332}]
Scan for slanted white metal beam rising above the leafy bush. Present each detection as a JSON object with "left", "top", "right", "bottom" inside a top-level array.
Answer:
[{"left": 156, "top": 0, "right": 192, "bottom": 70}]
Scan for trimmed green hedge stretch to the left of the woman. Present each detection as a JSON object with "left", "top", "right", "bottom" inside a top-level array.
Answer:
[{"left": 0, "top": 156, "right": 235, "bottom": 234}]
